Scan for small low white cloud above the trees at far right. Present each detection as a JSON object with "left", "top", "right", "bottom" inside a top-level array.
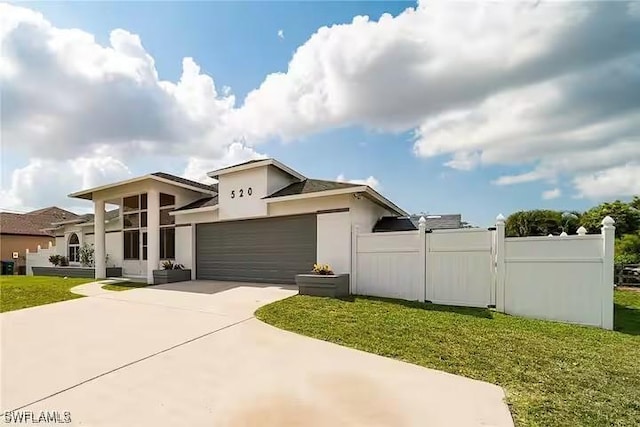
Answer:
[{"left": 573, "top": 163, "right": 640, "bottom": 199}]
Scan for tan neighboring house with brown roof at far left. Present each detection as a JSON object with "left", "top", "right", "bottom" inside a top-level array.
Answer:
[{"left": 0, "top": 206, "right": 78, "bottom": 271}]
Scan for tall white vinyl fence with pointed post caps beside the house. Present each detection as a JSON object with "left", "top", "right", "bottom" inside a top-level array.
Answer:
[{"left": 352, "top": 216, "right": 615, "bottom": 329}]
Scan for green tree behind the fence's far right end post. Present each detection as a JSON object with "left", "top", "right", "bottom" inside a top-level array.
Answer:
[{"left": 580, "top": 201, "right": 640, "bottom": 236}]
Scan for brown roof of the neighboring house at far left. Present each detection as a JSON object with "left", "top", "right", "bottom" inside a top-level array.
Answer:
[{"left": 0, "top": 206, "right": 78, "bottom": 236}]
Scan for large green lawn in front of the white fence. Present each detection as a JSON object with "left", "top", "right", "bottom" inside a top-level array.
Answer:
[{"left": 256, "top": 291, "right": 640, "bottom": 426}]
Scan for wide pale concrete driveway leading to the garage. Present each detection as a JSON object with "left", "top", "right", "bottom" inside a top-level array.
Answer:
[{"left": 0, "top": 281, "right": 512, "bottom": 426}]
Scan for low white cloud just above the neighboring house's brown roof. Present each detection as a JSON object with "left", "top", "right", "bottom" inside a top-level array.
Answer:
[{"left": 0, "top": 156, "right": 131, "bottom": 212}]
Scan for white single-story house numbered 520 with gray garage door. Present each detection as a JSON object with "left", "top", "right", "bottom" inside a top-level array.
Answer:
[{"left": 42, "top": 159, "right": 407, "bottom": 283}]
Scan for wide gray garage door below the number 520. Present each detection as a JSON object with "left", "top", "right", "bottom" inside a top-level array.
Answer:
[{"left": 196, "top": 214, "right": 317, "bottom": 283}]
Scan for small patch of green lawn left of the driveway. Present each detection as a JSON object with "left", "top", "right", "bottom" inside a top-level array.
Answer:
[{"left": 0, "top": 276, "right": 95, "bottom": 312}]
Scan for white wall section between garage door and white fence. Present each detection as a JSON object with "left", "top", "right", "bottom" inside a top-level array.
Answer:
[{"left": 316, "top": 211, "right": 351, "bottom": 273}]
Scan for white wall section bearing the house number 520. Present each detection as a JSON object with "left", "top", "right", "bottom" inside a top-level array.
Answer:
[{"left": 218, "top": 167, "right": 267, "bottom": 220}]
